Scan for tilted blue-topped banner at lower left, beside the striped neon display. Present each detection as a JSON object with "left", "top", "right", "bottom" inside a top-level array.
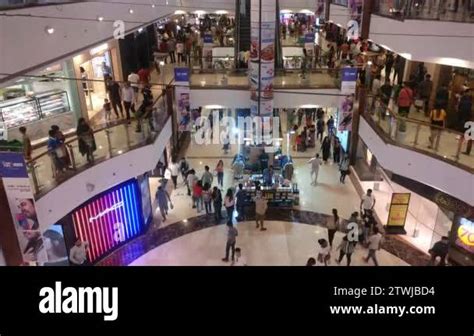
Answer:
[{"left": 0, "top": 152, "right": 47, "bottom": 264}]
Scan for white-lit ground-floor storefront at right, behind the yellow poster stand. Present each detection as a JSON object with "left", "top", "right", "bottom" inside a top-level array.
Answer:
[{"left": 354, "top": 138, "right": 474, "bottom": 264}]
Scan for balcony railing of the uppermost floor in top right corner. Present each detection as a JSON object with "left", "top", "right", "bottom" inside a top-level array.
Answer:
[{"left": 374, "top": 0, "right": 474, "bottom": 23}]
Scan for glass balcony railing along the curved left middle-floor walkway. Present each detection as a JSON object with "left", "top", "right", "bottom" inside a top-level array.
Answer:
[{"left": 0, "top": 90, "right": 170, "bottom": 198}]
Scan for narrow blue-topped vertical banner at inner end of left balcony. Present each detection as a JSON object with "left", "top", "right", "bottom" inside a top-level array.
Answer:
[{"left": 174, "top": 68, "right": 192, "bottom": 132}]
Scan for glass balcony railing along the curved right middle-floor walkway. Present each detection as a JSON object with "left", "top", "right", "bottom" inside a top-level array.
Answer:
[{"left": 363, "top": 93, "right": 474, "bottom": 173}]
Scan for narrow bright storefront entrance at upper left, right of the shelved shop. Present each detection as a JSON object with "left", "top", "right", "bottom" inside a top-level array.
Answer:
[{"left": 73, "top": 40, "right": 122, "bottom": 119}]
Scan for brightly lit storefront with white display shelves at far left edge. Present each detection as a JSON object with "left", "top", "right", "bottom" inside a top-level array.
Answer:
[{"left": 0, "top": 61, "right": 81, "bottom": 142}]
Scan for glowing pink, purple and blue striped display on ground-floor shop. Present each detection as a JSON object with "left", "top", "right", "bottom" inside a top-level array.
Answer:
[{"left": 72, "top": 180, "right": 143, "bottom": 262}]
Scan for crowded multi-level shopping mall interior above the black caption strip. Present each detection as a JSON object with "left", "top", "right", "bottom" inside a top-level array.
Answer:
[{"left": 0, "top": 0, "right": 474, "bottom": 267}]
